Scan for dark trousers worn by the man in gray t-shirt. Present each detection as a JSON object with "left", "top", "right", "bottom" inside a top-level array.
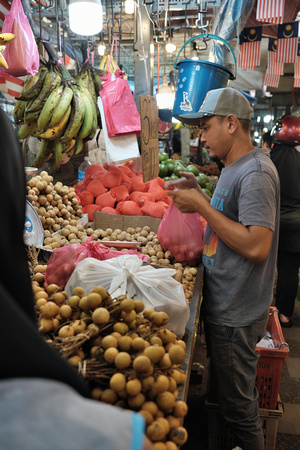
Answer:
[{"left": 205, "top": 311, "right": 268, "bottom": 450}]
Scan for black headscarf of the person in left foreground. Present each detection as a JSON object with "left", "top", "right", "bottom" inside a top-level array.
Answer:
[{"left": 0, "top": 108, "right": 90, "bottom": 397}]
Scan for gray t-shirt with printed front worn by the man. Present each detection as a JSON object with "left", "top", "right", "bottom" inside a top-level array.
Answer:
[{"left": 202, "top": 149, "right": 280, "bottom": 327}]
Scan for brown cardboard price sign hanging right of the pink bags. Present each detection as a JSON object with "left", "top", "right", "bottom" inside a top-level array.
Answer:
[{"left": 140, "top": 95, "right": 159, "bottom": 182}]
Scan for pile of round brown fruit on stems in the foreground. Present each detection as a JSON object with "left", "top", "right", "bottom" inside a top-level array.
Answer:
[{"left": 32, "top": 265, "right": 187, "bottom": 450}]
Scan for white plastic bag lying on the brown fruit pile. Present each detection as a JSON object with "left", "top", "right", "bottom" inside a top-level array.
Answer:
[{"left": 65, "top": 255, "right": 190, "bottom": 338}]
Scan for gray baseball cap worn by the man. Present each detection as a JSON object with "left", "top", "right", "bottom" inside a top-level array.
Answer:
[{"left": 179, "top": 88, "right": 253, "bottom": 125}]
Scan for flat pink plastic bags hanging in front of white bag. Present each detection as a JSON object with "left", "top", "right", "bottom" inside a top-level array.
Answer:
[{"left": 100, "top": 70, "right": 141, "bottom": 138}]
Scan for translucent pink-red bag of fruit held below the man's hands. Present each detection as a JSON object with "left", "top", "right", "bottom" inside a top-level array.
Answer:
[{"left": 157, "top": 201, "right": 204, "bottom": 266}]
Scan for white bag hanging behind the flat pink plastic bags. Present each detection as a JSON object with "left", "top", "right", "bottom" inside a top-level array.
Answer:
[{"left": 98, "top": 96, "right": 140, "bottom": 164}]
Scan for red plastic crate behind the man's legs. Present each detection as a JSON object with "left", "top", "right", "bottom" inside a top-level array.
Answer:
[{"left": 256, "top": 306, "right": 289, "bottom": 409}]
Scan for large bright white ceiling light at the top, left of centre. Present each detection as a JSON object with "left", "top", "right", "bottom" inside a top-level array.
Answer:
[{"left": 69, "top": 0, "right": 103, "bottom": 36}]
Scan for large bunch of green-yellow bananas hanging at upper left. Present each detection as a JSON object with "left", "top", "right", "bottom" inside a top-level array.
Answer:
[{"left": 13, "top": 59, "right": 101, "bottom": 169}]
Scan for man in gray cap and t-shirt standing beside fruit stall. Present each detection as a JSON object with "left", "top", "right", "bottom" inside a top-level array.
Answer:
[{"left": 169, "top": 88, "right": 280, "bottom": 450}]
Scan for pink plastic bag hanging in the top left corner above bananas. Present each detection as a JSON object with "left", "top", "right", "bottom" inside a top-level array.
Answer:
[{"left": 0, "top": 0, "right": 39, "bottom": 77}]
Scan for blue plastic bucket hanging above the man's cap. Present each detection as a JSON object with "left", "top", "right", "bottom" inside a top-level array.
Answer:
[{"left": 173, "top": 34, "right": 236, "bottom": 118}]
